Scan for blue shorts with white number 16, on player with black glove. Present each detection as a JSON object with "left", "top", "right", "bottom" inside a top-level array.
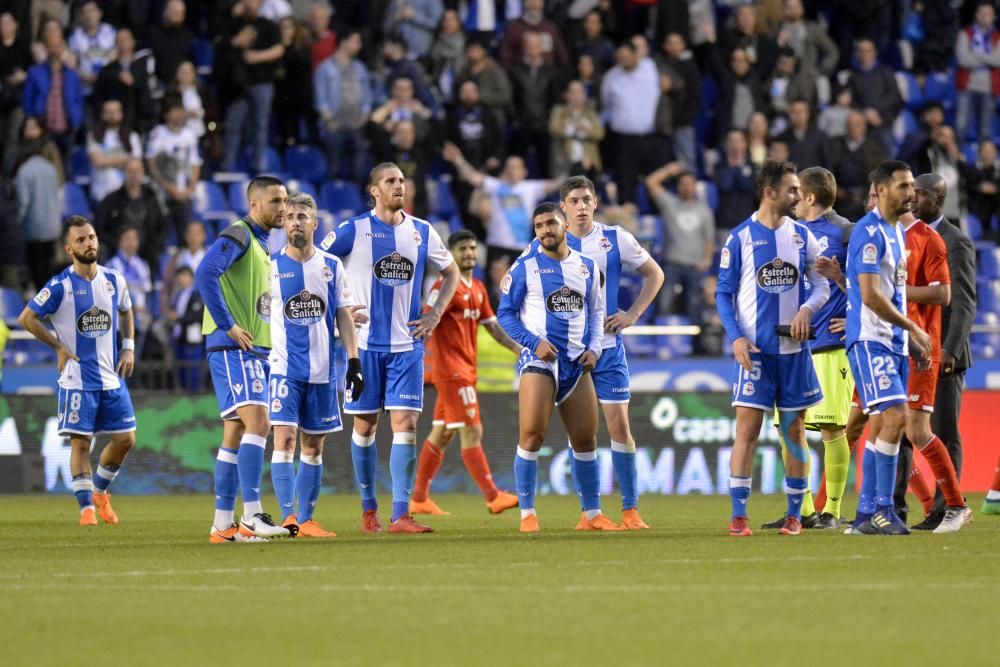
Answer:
[{"left": 268, "top": 375, "right": 343, "bottom": 435}]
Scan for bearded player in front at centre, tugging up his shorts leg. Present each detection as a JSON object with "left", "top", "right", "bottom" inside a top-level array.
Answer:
[{"left": 497, "top": 203, "right": 623, "bottom": 533}]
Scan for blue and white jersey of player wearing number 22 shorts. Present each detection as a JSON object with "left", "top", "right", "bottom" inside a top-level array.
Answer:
[{"left": 847, "top": 208, "right": 909, "bottom": 357}]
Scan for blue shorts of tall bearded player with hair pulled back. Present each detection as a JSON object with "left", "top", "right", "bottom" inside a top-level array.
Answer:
[{"left": 344, "top": 349, "right": 424, "bottom": 415}]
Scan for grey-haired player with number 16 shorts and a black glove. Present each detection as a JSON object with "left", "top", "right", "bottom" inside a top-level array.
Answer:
[{"left": 268, "top": 193, "right": 364, "bottom": 537}]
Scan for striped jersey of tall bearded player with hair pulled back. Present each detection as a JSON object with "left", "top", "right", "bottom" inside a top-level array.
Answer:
[{"left": 320, "top": 210, "right": 454, "bottom": 352}]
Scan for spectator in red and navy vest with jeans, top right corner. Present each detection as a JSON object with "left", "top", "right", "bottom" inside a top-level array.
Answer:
[{"left": 955, "top": 1, "right": 1000, "bottom": 141}]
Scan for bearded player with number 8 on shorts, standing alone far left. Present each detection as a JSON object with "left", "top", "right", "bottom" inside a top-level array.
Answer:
[{"left": 18, "top": 215, "right": 135, "bottom": 526}]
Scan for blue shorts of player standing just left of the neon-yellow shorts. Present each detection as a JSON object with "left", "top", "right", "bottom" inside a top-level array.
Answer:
[{"left": 733, "top": 349, "right": 823, "bottom": 412}]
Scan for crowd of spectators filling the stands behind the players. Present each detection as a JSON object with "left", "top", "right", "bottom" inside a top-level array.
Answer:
[{"left": 0, "top": 0, "right": 1000, "bottom": 386}]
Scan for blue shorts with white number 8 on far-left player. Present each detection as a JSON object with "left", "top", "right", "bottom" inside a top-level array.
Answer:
[{"left": 58, "top": 382, "right": 135, "bottom": 436}]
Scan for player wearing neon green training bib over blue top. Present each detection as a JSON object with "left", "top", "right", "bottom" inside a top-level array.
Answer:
[{"left": 195, "top": 176, "right": 291, "bottom": 544}]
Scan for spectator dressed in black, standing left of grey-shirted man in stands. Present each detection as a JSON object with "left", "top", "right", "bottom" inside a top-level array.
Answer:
[{"left": 274, "top": 16, "right": 315, "bottom": 146}]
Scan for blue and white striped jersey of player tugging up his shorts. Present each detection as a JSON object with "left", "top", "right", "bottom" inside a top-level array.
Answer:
[{"left": 497, "top": 250, "right": 605, "bottom": 361}]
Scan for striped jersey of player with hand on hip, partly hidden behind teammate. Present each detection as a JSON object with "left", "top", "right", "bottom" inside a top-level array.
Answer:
[{"left": 521, "top": 222, "right": 649, "bottom": 349}]
